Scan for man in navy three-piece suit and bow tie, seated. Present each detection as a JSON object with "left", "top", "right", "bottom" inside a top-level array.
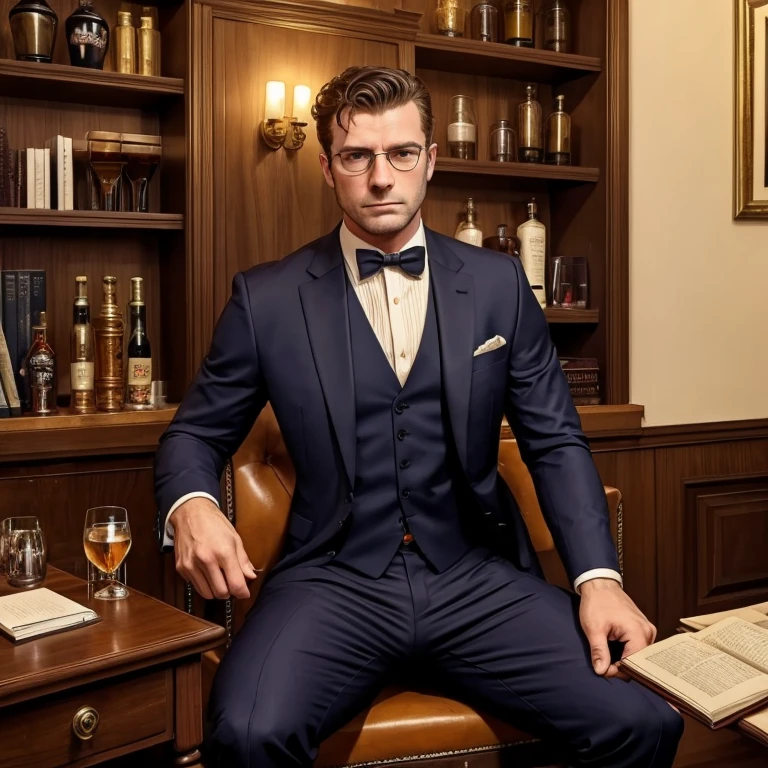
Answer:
[{"left": 156, "top": 67, "right": 682, "bottom": 768}]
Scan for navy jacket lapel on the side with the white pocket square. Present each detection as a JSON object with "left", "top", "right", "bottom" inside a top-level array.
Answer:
[{"left": 424, "top": 227, "right": 475, "bottom": 467}]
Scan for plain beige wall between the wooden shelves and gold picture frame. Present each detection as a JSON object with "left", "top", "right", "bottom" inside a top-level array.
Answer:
[{"left": 629, "top": 0, "right": 768, "bottom": 426}]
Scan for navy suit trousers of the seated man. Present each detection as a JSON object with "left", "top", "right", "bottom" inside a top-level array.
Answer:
[{"left": 206, "top": 547, "right": 683, "bottom": 768}]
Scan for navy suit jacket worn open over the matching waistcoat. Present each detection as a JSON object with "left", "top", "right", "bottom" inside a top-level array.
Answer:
[{"left": 155, "top": 227, "right": 618, "bottom": 580}]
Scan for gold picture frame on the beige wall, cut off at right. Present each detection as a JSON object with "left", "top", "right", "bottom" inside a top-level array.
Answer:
[{"left": 733, "top": 0, "right": 768, "bottom": 219}]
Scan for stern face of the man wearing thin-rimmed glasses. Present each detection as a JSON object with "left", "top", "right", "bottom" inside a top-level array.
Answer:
[{"left": 320, "top": 102, "right": 437, "bottom": 245}]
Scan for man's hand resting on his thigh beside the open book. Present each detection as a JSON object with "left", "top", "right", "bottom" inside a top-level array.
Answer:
[{"left": 579, "top": 579, "right": 656, "bottom": 677}]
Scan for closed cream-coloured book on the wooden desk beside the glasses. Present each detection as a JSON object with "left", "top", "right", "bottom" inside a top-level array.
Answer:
[{"left": 0, "top": 587, "right": 101, "bottom": 643}]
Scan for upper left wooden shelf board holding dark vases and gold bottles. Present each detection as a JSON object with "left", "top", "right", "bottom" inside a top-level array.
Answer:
[{"left": 0, "top": 59, "right": 184, "bottom": 109}]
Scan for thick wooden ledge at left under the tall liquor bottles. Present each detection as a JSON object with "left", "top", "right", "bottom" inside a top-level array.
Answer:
[{"left": 0, "top": 405, "right": 176, "bottom": 461}]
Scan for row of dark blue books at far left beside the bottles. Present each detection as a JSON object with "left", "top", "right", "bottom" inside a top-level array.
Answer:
[{"left": 0, "top": 269, "right": 46, "bottom": 418}]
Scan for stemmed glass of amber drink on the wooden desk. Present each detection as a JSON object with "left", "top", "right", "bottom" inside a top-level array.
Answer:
[{"left": 83, "top": 507, "right": 131, "bottom": 600}]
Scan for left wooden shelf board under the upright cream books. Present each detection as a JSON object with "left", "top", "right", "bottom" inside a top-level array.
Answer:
[{"left": 0, "top": 208, "right": 184, "bottom": 230}]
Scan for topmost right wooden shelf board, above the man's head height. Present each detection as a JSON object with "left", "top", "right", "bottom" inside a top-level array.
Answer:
[{"left": 416, "top": 34, "right": 602, "bottom": 83}]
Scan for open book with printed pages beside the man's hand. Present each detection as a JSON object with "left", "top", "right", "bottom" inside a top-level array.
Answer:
[{"left": 622, "top": 625, "right": 768, "bottom": 722}]
